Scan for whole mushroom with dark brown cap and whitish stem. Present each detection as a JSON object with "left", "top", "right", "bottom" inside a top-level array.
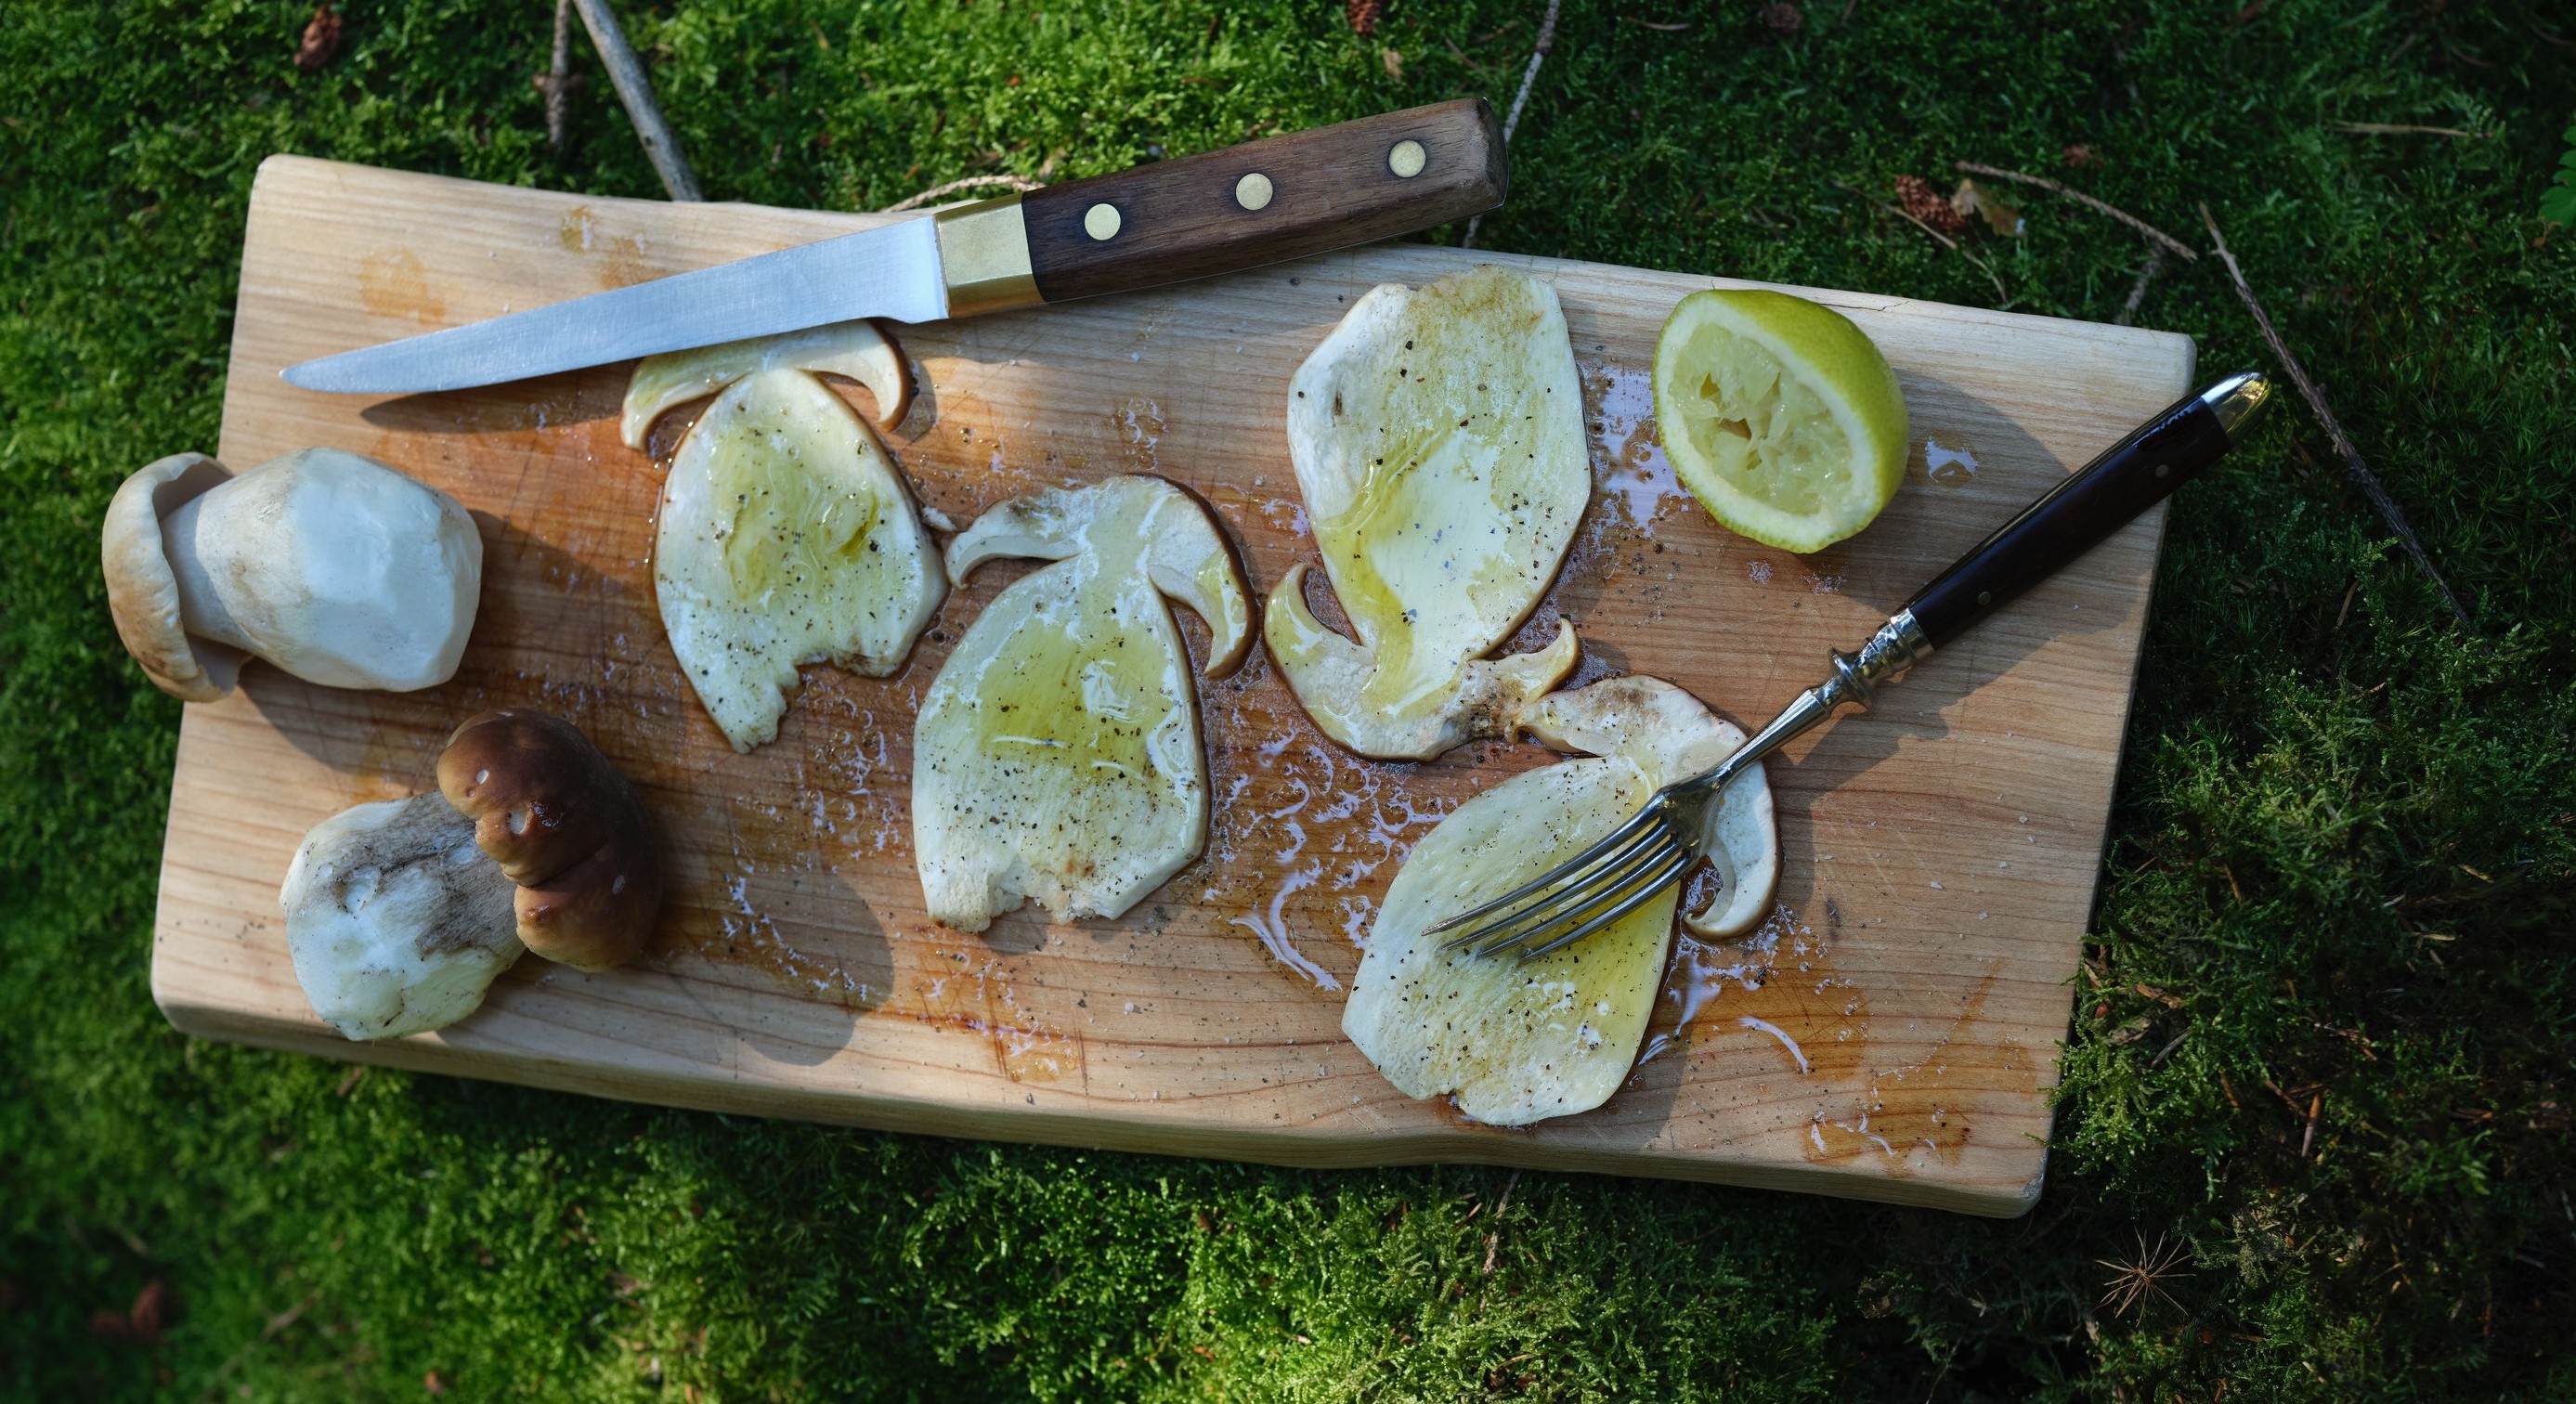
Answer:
[{"left": 279, "top": 711, "right": 662, "bottom": 1038}]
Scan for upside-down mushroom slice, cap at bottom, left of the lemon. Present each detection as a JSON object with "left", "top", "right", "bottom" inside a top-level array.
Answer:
[{"left": 1262, "top": 266, "right": 1592, "bottom": 760}]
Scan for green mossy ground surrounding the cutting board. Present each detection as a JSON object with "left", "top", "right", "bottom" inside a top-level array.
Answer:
[{"left": 0, "top": 0, "right": 2576, "bottom": 1401}]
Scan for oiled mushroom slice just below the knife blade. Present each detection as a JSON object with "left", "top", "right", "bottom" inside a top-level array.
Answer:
[{"left": 626, "top": 322, "right": 948, "bottom": 749}]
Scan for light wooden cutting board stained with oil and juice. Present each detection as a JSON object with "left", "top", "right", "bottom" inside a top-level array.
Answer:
[{"left": 152, "top": 157, "right": 2192, "bottom": 1214}]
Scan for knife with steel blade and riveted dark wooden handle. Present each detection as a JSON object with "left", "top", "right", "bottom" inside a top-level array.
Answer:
[{"left": 280, "top": 98, "right": 1510, "bottom": 394}]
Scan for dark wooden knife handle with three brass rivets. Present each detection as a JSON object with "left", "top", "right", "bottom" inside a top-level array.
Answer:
[{"left": 1021, "top": 98, "right": 1510, "bottom": 302}]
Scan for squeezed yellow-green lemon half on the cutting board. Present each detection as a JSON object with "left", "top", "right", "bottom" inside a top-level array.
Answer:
[{"left": 1654, "top": 289, "right": 1906, "bottom": 553}]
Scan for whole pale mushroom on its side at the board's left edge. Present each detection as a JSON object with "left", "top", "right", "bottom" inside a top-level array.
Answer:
[{"left": 98, "top": 448, "right": 482, "bottom": 701}]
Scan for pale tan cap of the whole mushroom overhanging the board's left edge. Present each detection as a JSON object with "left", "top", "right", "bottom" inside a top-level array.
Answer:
[{"left": 98, "top": 453, "right": 242, "bottom": 701}]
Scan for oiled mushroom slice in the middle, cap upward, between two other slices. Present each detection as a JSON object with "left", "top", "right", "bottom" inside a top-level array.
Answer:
[{"left": 912, "top": 476, "right": 1252, "bottom": 930}]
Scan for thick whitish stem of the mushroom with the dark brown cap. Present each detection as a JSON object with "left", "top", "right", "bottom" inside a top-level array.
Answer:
[{"left": 279, "top": 793, "right": 523, "bottom": 1041}]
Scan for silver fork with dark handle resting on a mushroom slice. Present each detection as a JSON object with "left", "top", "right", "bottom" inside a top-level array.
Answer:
[{"left": 1430, "top": 371, "right": 2272, "bottom": 961}]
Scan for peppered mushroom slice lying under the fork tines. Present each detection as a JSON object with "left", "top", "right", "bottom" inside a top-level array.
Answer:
[{"left": 1342, "top": 678, "right": 1780, "bottom": 1125}]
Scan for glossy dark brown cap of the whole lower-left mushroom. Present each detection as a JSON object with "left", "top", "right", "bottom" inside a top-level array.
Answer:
[{"left": 438, "top": 708, "right": 662, "bottom": 971}]
